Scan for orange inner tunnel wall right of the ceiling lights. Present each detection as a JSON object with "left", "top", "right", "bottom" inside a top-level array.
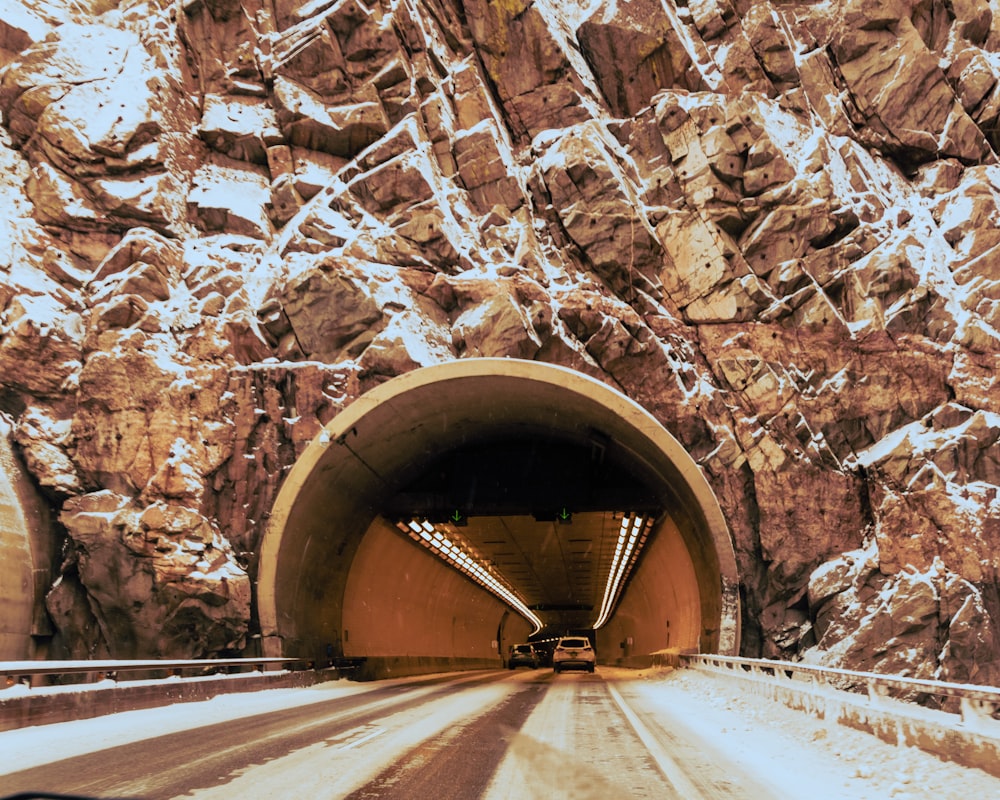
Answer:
[{"left": 597, "top": 517, "right": 702, "bottom": 667}]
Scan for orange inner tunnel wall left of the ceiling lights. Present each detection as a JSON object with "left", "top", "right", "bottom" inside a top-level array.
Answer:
[{"left": 343, "top": 517, "right": 530, "bottom": 677}]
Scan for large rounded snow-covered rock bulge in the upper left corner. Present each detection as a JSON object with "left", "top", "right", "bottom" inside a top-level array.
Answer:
[{"left": 0, "top": 15, "right": 202, "bottom": 234}]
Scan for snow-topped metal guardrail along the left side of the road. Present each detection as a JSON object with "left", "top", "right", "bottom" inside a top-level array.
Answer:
[{"left": 0, "top": 658, "right": 312, "bottom": 686}]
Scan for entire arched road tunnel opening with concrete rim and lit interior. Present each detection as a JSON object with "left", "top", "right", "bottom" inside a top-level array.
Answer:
[{"left": 257, "top": 358, "right": 740, "bottom": 677}]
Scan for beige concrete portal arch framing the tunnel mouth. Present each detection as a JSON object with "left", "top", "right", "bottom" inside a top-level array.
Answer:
[{"left": 257, "top": 358, "right": 740, "bottom": 668}]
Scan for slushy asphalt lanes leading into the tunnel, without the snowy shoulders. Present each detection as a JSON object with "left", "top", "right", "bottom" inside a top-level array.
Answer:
[{"left": 0, "top": 669, "right": 770, "bottom": 800}]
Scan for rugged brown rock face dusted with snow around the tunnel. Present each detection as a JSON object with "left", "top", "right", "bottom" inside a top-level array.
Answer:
[{"left": 0, "top": 0, "right": 1000, "bottom": 682}]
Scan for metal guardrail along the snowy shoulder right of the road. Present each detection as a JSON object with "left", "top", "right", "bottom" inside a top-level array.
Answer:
[{"left": 679, "top": 653, "right": 1000, "bottom": 727}]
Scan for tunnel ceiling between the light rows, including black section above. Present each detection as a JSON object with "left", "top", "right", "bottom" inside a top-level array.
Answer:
[{"left": 382, "top": 431, "right": 663, "bottom": 628}]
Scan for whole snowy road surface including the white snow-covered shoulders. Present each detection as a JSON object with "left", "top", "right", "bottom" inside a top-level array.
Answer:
[{"left": 0, "top": 668, "right": 1000, "bottom": 800}]
